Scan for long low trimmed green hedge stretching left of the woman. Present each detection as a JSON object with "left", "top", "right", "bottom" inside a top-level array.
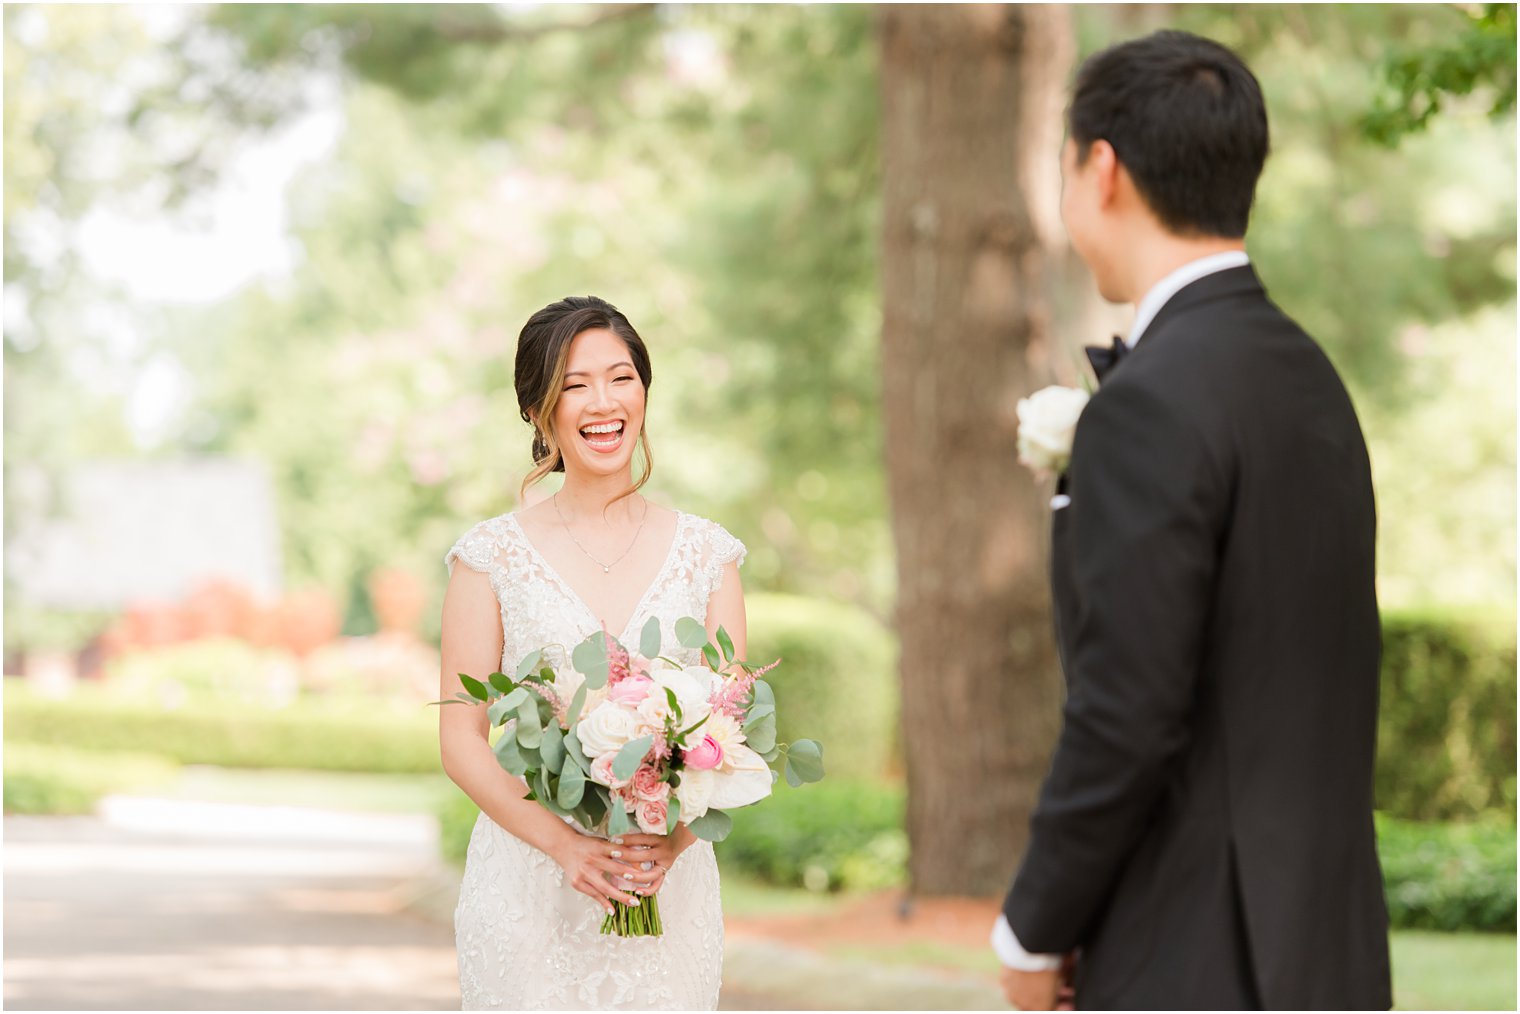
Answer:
[{"left": 5, "top": 690, "right": 439, "bottom": 774}]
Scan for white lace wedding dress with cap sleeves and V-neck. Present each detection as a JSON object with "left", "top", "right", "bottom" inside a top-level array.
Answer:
[{"left": 444, "top": 514, "right": 745, "bottom": 1011}]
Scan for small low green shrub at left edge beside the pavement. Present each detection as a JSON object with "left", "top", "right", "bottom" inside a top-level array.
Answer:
[{"left": 5, "top": 742, "right": 176, "bottom": 813}]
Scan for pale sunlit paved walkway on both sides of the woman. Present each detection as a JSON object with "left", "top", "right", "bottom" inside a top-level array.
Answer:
[{"left": 5, "top": 797, "right": 1002, "bottom": 1011}]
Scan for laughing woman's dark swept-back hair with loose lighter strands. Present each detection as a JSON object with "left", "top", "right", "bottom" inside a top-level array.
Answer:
[{"left": 514, "top": 296, "right": 654, "bottom": 496}]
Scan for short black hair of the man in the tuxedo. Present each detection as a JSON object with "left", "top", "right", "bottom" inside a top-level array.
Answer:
[{"left": 1067, "top": 32, "right": 1268, "bottom": 239}]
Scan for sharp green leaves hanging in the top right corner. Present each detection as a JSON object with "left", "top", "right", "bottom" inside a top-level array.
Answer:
[{"left": 1363, "top": 3, "right": 1515, "bottom": 146}]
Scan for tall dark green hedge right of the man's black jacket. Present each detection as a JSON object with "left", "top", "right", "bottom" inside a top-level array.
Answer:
[{"left": 1376, "top": 610, "right": 1515, "bottom": 821}]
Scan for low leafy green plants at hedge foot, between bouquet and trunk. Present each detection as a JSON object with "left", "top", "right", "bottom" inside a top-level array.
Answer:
[{"left": 717, "top": 780, "right": 907, "bottom": 891}]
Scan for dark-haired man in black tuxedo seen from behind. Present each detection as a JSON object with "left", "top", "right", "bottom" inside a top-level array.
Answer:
[{"left": 993, "top": 32, "right": 1391, "bottom": 1009}]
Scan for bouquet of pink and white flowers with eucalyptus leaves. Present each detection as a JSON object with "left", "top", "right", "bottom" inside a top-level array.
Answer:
[{"left": 440, "top": 617, "right": 824, "bottom": 936}]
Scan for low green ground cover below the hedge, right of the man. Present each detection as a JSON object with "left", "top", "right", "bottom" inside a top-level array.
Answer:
[{"left": 1377, "top": 815, "right": 1515, "bottom": 933}]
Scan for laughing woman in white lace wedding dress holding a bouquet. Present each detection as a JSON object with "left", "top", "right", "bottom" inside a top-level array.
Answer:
[{"left": 438, "top": 296, "right": 745, "bottom": 1009}]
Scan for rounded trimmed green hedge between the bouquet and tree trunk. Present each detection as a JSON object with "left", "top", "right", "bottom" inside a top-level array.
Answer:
[{"left": 745, "top": 593, "right": 900, "bottom": 778}]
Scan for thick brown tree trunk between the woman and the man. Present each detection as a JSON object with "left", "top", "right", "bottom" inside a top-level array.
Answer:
[{"left": 880, "top": 5, "right": 1073, "bottom": 895}]
